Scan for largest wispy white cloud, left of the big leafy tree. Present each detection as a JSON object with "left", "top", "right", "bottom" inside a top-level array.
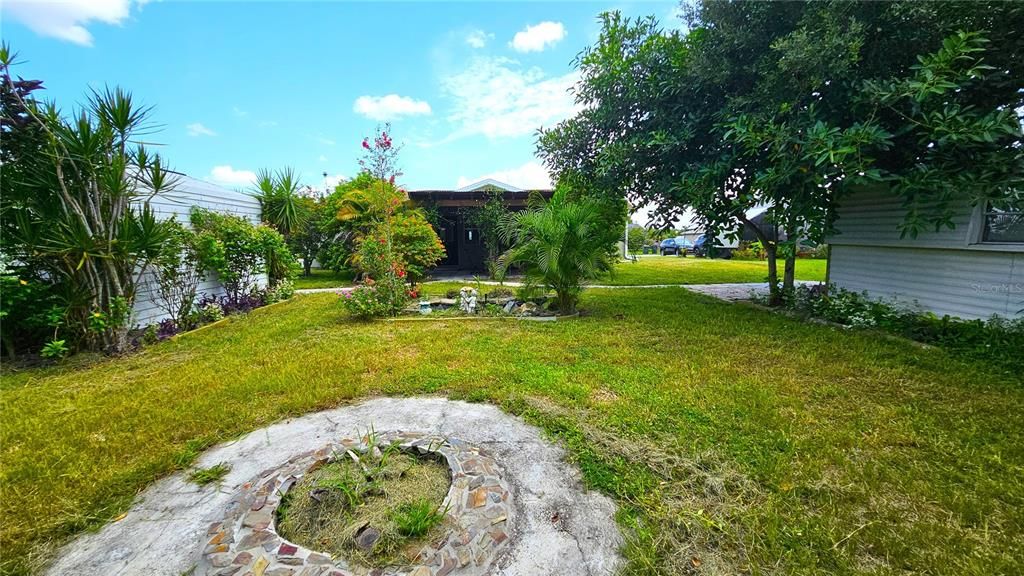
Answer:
[{"left": 441, "top": 57, "right": 579, "bottom": 140}]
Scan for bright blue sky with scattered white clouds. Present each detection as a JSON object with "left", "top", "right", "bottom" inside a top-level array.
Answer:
[{"left": 2, "top": 0, "right": 676, "bottom": 194}]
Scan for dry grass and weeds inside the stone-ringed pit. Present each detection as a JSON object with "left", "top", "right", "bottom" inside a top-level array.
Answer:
[{"left": 276, "top": 439, "right": 452, "bottom": 568}]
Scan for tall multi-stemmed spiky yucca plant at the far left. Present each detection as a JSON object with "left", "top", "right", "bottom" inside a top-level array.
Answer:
[{"left": 0, "top": 45, "right": 175, "bottom": 354}]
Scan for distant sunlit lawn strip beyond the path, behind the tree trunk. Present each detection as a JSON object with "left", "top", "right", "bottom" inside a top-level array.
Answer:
[{"left": 598, "top": 256, "right": 827, "bottom": 286}]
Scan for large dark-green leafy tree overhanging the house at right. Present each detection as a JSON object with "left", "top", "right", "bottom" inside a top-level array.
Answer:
[{"left": 541, "top": 0, "right": 1024, "bottom": 297}]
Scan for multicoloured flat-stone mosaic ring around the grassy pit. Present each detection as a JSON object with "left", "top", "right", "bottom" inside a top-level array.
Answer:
[{"left": 199, "top": 431, "right": 514, "bottom": 576}]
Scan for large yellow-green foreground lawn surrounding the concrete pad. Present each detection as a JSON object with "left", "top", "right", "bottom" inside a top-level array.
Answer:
[{"left": 0, "top": 289, "right": 1024, "bottom": 575}]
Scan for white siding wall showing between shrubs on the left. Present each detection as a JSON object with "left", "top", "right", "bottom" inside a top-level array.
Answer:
[{"left": 132, "top": 176, "right": 267, "bottom": 326}]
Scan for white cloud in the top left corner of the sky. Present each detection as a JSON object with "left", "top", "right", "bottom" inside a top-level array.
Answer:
[{"left": 3, "top": 0, "right": 144, "bottom": 46}]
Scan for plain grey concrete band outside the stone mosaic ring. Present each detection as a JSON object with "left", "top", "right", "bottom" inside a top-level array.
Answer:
[{"left": 47, "top": 398, "right": 622, "bottom": 576}]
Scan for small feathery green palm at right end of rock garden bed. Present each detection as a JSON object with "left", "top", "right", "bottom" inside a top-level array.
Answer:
[{"left": 498, "top": 188, "right": 613, "bottom": 314}]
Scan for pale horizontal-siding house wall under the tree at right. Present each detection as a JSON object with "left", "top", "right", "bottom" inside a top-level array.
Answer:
[{"left": 828, "top": 190, "right": 1024, "bottom": 319}]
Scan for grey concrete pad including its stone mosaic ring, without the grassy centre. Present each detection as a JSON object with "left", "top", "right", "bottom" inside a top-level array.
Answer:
[{"left": 47, "top": 398, "right": 622, "bottom": 576}]
